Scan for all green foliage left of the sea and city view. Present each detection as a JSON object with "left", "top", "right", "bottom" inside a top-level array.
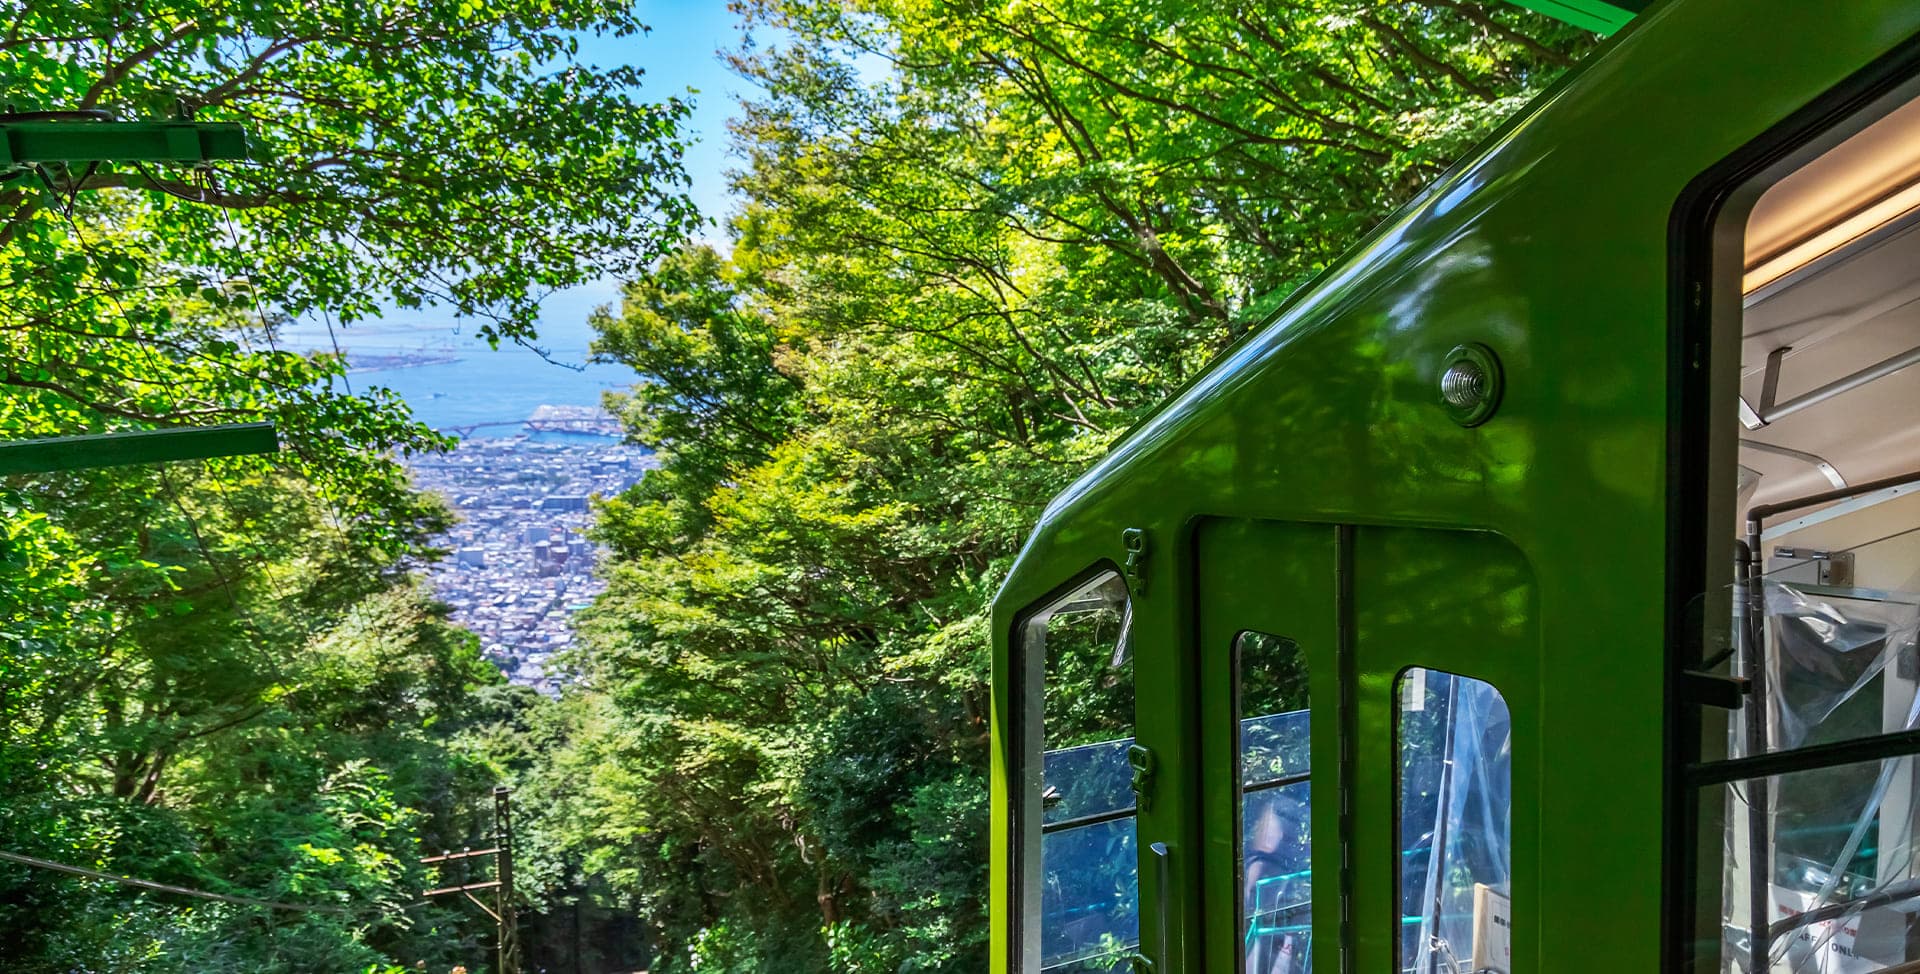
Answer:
[{"left": 0, "top": 0, "right": 697, "bottom": 974}]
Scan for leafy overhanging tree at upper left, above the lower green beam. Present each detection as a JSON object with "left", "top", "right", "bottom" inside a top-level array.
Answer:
[{"left": 0, "top": 0, "right": 697, "bottom": 526}]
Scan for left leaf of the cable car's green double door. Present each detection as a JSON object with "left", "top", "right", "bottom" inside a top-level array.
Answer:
[{"left": 1194, "top": 519, "right": 1340, "bottom": 974}]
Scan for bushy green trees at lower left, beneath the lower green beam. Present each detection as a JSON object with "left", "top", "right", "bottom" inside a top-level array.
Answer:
[{"left": 0, "top": 471, "right": 501, "bottom": 972}]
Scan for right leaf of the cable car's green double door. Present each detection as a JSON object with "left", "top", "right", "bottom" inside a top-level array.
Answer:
[{"left": 1342, "top": 526, "right": 1543, "bottom": 974}]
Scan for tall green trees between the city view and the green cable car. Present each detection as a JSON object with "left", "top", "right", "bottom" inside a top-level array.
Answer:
[{"left": 528, "top": 0, "right": 1592, "bottom": 972}]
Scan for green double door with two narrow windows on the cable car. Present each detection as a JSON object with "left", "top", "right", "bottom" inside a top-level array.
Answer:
[{"left": 1194, "top": 519, "right": 1538, "bottom": 974}]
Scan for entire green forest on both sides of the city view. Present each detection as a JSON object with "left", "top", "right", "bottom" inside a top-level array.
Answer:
[{"left": 0, "top": 0, "right": 1596, "bottom": 974}]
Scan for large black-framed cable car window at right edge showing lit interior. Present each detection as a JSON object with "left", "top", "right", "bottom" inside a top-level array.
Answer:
[{"left": 1670, "top": 86, "right": 1920, "bottom": 974}]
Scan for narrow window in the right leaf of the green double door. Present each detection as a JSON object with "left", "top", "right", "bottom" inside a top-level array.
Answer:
[{"left": 1396, "top": 669, "right": 1513, "bottom": 974}]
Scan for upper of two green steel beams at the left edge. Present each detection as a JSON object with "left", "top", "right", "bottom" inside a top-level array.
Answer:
[{"left": 0, "top": 119, "right": 246, "bottom": 165}]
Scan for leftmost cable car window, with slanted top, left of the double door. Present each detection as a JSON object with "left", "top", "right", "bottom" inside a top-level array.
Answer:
[{"left": 1016, "top": 572, "right": 1140, "bottom": 974}]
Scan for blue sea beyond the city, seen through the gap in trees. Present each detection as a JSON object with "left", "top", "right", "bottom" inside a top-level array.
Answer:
[{"left": 278, "top": 286, "right": 637, "bottom": 442}]
